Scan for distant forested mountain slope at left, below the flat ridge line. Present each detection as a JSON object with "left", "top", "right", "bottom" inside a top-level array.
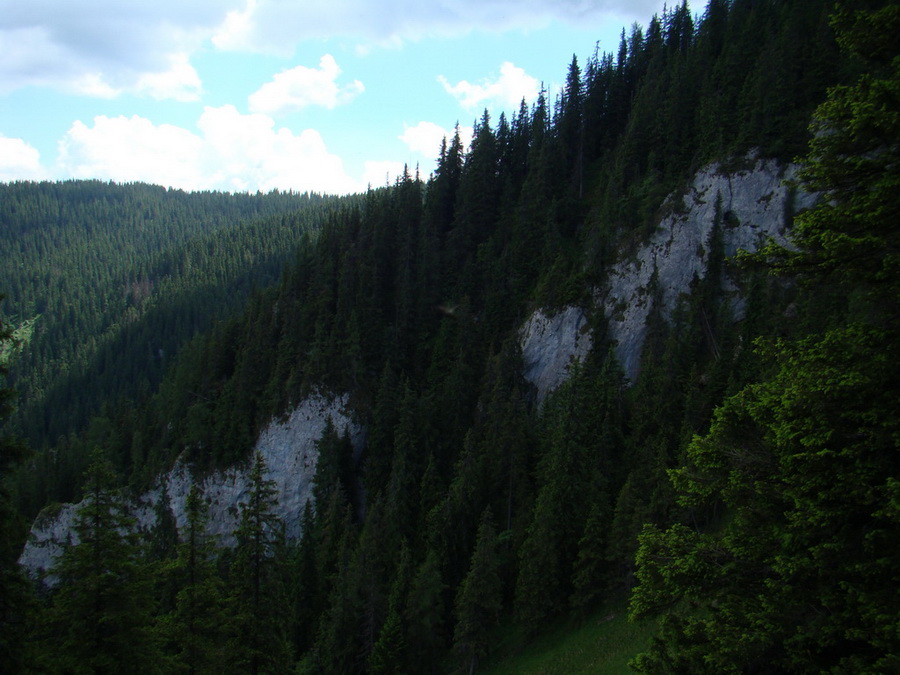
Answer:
[{"left": 0, "top": 181, "right": 352, "bottom": 510}]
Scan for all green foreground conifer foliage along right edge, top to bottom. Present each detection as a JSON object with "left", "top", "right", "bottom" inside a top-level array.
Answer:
[{"left": 632, "top": 4, "right": 900, "bottom": 673}]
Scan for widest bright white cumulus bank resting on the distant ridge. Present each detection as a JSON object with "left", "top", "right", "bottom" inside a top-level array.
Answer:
[{"left": 58, "top": 105, "right": 365, "bottom": 194}]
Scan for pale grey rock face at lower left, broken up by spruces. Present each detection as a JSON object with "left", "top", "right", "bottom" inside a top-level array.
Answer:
[{"left": 19, "top": 395, "right": 361, "bottom": 575}]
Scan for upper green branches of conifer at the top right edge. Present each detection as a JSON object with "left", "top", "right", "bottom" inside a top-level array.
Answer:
[{"left": 770, "top": 4, "right": 900, "bottom": 304}]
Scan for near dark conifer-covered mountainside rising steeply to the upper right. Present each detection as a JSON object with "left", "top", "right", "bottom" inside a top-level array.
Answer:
[{"left": 3, "top": 0, "right": 900, "bottom": 673}]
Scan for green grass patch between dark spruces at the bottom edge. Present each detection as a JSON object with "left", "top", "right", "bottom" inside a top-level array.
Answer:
[{"left": 479, "top": 606, "right": 656, "bottom": 675}]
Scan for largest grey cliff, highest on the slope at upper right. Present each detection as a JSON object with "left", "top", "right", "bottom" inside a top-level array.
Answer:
[{"left": 596, "top": 155, "right": 816, "bottom": 380}]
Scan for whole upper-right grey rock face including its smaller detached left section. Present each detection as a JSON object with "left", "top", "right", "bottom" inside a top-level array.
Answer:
[{"left": 519, "top": 159, "right": 816, "bottom": 390}]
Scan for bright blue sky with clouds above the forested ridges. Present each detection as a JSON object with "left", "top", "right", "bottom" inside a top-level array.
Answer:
[{"left": 0, "top": 0, "right": 662, "bottom": 194}]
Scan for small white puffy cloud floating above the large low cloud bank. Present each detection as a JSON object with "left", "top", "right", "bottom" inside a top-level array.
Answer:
[{"left": 247, "top": 54, "right": 365, "bottom": 114}]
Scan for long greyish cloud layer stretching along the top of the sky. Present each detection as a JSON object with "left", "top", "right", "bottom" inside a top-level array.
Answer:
[{"left": 0, "top": 0, "right": 660, "bottom": 100}]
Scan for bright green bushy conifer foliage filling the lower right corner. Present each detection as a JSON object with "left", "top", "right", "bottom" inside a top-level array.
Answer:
[{"left": 632, "top": 326, "right": 900, "bottom": 672}]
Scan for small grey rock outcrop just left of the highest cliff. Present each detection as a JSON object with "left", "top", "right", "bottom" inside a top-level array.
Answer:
[{"left": 519, "top": 307, "right": 592, "bottom": 405}]
